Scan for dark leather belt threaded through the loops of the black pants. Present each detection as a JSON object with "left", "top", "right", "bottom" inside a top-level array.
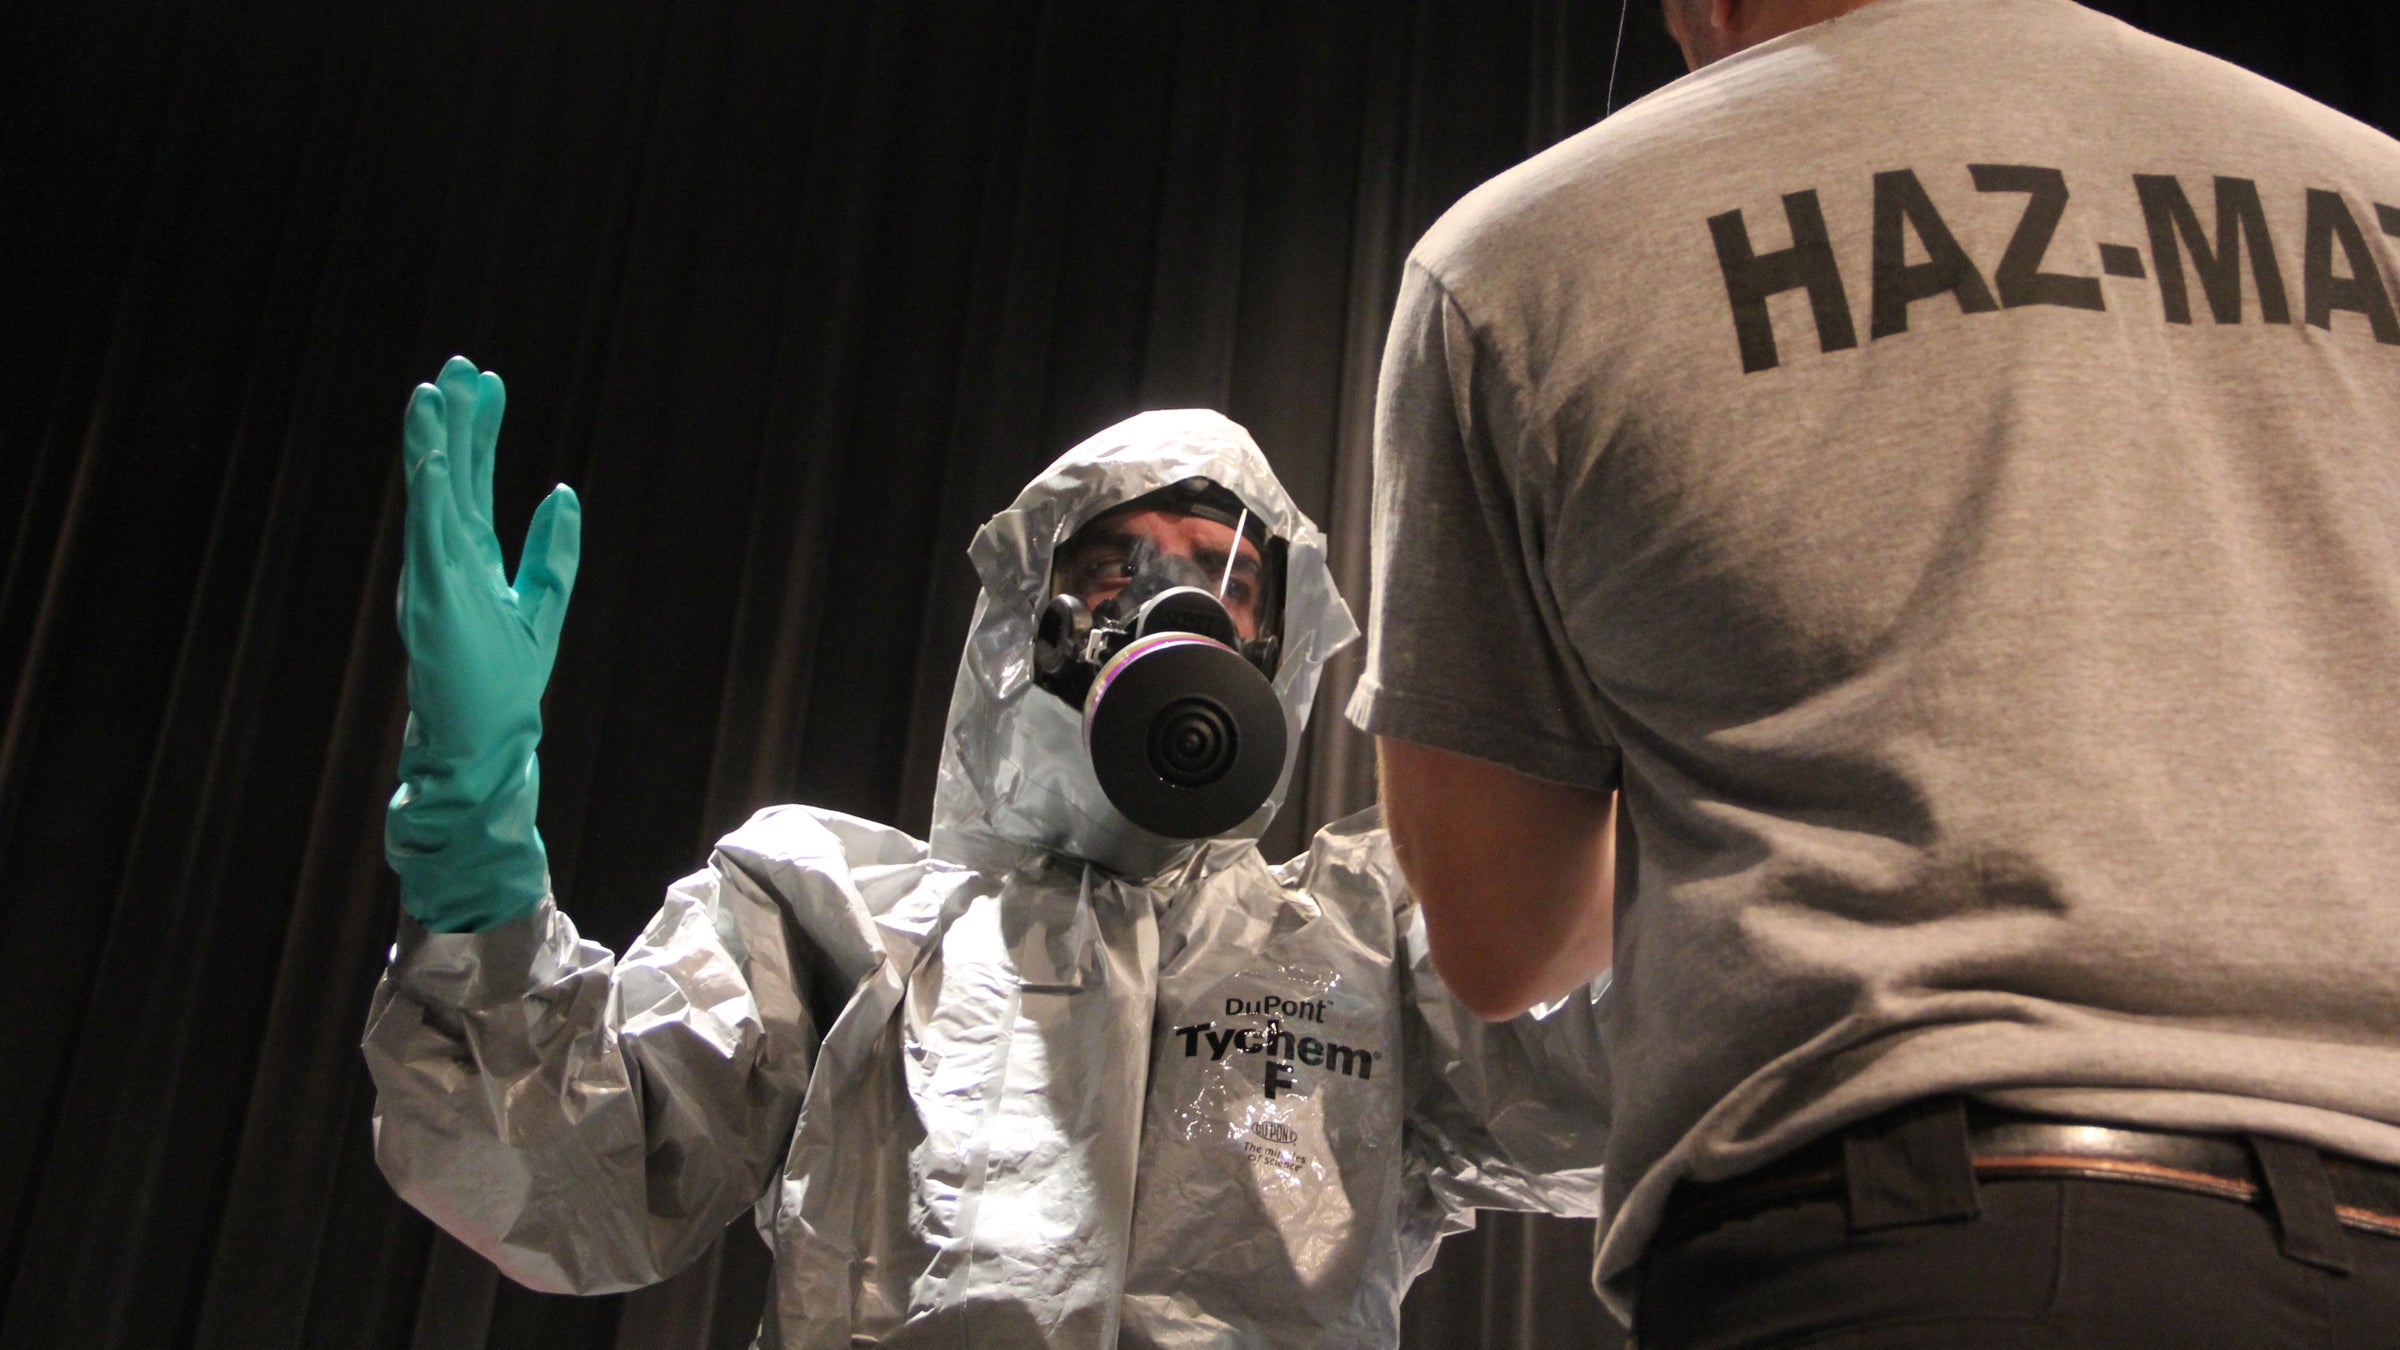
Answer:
[{"left": 1651, "top": 1103, "right": 2400, "bottom": 1249}]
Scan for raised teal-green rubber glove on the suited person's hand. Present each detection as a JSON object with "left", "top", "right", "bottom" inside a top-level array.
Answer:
[{"left": 384, "top": 356, "right": 583, "bottom": 932}]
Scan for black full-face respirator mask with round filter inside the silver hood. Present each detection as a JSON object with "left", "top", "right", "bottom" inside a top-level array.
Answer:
[{"left": 1034, "top": 478, "right": 1286, "bottom": 838}]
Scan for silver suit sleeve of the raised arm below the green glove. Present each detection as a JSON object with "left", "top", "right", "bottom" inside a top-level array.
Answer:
[{"left": 362, "top": 810, "right": 922, "bottom": 1295}]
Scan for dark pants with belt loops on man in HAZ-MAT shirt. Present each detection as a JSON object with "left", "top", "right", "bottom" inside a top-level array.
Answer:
[{"left": 1634, "top": 1100, "right": 2400, "bottom": 1350}]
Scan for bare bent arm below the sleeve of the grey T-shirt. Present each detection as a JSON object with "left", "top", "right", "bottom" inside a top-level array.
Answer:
[{"left": 1375, "top": 737, "right": 1615, "bottom": 1021}]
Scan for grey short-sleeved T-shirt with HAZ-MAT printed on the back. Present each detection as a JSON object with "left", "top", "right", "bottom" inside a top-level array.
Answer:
[{"left": 1351, "top": 0, "right": 2400, "bottom": 1307}]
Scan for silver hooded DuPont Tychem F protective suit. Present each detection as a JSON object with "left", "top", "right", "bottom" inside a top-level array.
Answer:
[{"left": 365, "top": 411, "right": 1606, "bottom": 1348}]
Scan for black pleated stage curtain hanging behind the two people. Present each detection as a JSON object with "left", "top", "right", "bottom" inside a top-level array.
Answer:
[{"left": 0, "top": 0, "right": 2400, "bottom": 1350}]
